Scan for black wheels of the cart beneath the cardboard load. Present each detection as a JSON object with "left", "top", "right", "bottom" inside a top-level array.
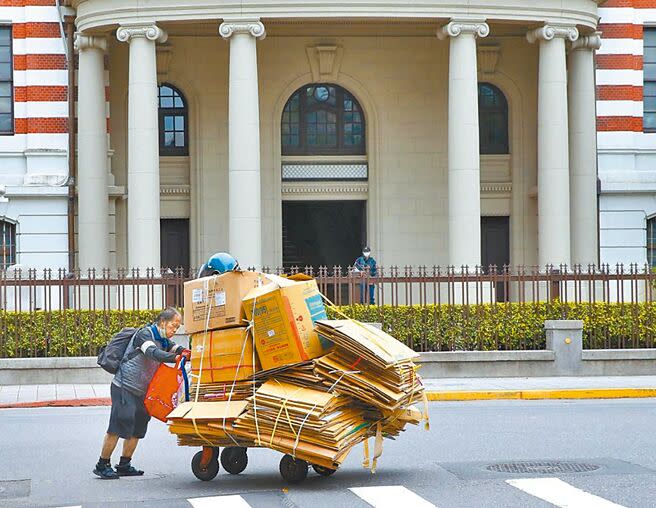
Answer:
[{"left": 191, "top": 446, "right": 337, "bottom": 483}]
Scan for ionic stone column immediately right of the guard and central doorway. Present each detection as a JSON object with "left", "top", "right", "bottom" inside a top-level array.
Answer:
[{"left": 437, "top": 20, "right": 490, "bottom": 270}]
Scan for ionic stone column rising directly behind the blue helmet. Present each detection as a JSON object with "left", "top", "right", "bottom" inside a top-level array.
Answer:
[{"left": 219, "top": 19, "right": 265, "bottom": 268}]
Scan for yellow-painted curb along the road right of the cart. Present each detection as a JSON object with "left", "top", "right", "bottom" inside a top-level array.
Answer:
[{"left": 426, "top": 388, "right": 656, "bottom": 402}]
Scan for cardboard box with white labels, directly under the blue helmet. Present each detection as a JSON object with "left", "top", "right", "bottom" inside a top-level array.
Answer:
[{"left": 184, "top": 272, "right": 269, "bottom": 333}]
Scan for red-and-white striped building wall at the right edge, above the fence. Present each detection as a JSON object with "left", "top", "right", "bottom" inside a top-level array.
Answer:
[{"left": 597, "top": 0, "right": 656, "bottom": 267}]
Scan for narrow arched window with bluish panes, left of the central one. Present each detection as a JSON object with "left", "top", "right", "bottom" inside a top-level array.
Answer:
[{"left": 159, "top": 83, "right": 189, "bottom": 155}]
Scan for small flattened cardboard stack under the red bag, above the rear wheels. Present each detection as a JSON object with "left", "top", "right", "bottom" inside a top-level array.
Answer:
[{"left": 168, "top": 400, "right": 253, "bottom": 446}]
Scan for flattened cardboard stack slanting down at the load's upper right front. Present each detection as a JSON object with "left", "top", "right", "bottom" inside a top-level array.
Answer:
[{"left": 315, "top": 320, "right": 423, "bottom": 411}]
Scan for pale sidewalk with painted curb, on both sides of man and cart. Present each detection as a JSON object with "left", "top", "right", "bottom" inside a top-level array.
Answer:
[{"left": 0, "top": 376, "right": 656, "bottom": 408}]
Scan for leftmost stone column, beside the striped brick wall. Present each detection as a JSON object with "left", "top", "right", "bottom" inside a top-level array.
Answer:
[{"left": 76, "top": 33, "right": 109, "bottom": 275}]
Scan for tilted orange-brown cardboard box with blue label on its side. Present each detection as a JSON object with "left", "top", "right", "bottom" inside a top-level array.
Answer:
[{"left": 244, "top": 276, "right": 332, "bottom": 370}]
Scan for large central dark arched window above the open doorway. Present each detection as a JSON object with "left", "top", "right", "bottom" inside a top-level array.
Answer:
[{"left": 281, "top": 83, "right": 366, "bottom": 155}]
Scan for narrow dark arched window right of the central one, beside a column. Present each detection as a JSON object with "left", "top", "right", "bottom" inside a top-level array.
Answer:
[{"left": 478, "top": 83, "right": 509, "bottom": 155}]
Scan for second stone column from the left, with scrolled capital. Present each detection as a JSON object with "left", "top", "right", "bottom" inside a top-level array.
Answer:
[{"left": 116, "top": 24, "right": 167, "bottom": 270}]
